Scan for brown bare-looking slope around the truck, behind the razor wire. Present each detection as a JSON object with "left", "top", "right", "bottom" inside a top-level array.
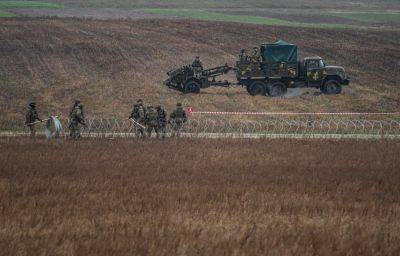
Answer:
[{"left": 0, "top": 18, "right": 400, "bottom": 127}]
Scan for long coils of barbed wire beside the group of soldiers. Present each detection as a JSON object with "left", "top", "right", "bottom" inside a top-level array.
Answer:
[{"left": 56, "top": 117, "right": 400, "bottom": 136}]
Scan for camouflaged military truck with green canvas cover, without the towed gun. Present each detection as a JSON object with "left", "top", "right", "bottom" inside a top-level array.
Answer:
[{"left": 238, "top": 40, "right": 350, "bottom": 97}]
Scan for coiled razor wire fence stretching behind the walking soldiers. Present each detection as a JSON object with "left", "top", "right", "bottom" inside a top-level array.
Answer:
[{"left": 3, "top": 114, "right": 400, "bottom": 137}]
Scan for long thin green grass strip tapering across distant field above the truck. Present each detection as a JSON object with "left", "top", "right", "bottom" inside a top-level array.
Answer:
[{"left": 141, "top": 8, "right": 357, "bottom": 28}]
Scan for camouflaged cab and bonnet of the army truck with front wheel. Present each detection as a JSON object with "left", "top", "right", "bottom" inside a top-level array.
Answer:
[{"left": 298, "top": 56, "right": 349, "bottom": 94}]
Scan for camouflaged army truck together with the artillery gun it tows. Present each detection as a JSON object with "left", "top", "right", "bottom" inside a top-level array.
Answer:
[{"left": 164, "top": 40, "right": 350, "bottom": 97}]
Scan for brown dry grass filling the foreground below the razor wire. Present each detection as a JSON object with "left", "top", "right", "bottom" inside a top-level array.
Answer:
[{"left": 0, "top": 139, "right": 400, "bottom": 255}]
